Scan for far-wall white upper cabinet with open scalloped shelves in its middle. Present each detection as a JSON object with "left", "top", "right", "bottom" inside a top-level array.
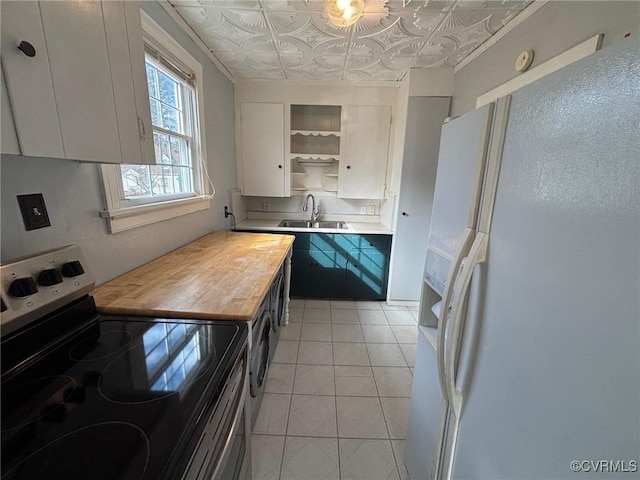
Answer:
[{"left": 235, "top": 81, "right": 399, "bottom": 200}]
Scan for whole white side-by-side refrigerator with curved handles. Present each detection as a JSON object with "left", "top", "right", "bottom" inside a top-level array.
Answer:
[{"left": 405, "top": 40, "right": 640, "bottom": 480}]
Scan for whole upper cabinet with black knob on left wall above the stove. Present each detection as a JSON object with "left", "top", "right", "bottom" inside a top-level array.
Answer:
[{"left": 2, "top": 1, "right": 154, "bottom": 164}]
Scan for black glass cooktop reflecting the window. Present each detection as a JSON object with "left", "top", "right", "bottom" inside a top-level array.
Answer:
[{"left": 0, "top": 298, "right": 247, "bottom": 480}]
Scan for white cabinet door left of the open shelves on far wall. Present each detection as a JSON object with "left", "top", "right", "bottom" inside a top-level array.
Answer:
[{"left": 240, "top": 103, "right": 288, "bottom": 197}]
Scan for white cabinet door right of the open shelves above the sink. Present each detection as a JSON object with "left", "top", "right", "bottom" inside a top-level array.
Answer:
[{"left": 338, "top": 105, "right": 391, "bottom": 199}]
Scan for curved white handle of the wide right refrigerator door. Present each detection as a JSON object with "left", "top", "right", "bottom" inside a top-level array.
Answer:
[{"left": 444, "top": 232, "right": 489, "bottom": 419}]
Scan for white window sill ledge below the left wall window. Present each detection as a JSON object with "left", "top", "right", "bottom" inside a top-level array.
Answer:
[{"left": 100, "top": 196, "right": 211, "bottom": 233}]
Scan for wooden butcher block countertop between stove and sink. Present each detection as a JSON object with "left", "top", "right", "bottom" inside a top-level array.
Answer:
[{"left": 91, "top": 232, "right": 295, "bottom": 321}]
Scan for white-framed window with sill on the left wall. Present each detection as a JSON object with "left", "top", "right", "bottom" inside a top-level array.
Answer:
[{"left": 101, "top": 12, "right": 213, "bottom": 233}]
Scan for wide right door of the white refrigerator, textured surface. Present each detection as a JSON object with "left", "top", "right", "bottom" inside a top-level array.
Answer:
[{"left": 452, "top": 40, "right": 640, "bottom": 480}]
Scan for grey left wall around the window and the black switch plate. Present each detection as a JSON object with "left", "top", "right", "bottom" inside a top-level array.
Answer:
[{"left": 0, "top": 2, "right": 236, "bottom": 283}]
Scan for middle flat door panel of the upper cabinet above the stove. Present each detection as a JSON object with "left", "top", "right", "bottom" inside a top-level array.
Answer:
[{"left": 40, "top": 1, "right": 122, "bottom": 163}]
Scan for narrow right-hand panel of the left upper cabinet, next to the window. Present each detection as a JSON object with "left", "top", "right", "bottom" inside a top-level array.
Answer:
[{"left": 102, "top": 2, "right": 155, "bottom": 165}]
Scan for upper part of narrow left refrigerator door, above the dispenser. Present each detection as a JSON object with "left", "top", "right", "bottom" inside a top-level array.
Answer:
[{"left": 425, "top": 104, "right": 493, "bottom": 296}]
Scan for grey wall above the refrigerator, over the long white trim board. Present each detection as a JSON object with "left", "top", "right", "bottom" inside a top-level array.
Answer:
[{"left": 450, "top": 0, "right": 640, "bottom": 116}]
